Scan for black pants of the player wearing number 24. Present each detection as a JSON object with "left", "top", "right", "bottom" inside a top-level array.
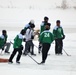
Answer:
[{"left": 42, "top": 43, "right": 50, "bottom": 62}]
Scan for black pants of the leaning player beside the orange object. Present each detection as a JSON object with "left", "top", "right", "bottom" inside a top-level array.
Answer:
[{"left": 9, "top": 48, "right": 22, "bottom": 61}]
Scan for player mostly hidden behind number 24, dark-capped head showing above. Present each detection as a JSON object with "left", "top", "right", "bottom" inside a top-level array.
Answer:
[{"left": 38, "top": 16, "right": 49, "bottom": 53}]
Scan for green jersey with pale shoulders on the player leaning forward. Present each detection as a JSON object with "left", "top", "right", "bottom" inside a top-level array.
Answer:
[{"left": 13, "top": 34, "right": 23, "bottom": 48}]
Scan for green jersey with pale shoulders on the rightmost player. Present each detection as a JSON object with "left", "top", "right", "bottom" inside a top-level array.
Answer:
[{"left": 53, "top": 26, "right": 64, "bottom": 39}]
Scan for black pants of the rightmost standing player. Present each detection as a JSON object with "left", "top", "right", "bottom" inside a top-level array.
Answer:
[{"left": 55, "top": 39, "right": 63, "bottom": 54}]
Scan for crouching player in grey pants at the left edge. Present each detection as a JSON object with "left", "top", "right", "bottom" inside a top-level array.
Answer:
[{"left": 0, "top": 30, "right": 11, "bottom": 53}]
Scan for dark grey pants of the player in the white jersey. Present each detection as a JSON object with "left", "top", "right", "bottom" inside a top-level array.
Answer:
[{"left": 24, "top": 40, "right": 34, "bottom": 54}]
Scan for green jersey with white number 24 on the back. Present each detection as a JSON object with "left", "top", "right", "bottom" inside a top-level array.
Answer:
[{"left": 39, "top": 30, "right": 54, "bottom": 44}]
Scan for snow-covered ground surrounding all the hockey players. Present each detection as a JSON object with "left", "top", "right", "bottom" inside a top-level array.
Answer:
[{"left": 0, "top": 0, "right": 76, "bottom": 75}]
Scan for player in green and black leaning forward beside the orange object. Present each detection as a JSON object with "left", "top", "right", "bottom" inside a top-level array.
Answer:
[{"left": 9, "top": 29, "right": 25, "bottom": 64}]
